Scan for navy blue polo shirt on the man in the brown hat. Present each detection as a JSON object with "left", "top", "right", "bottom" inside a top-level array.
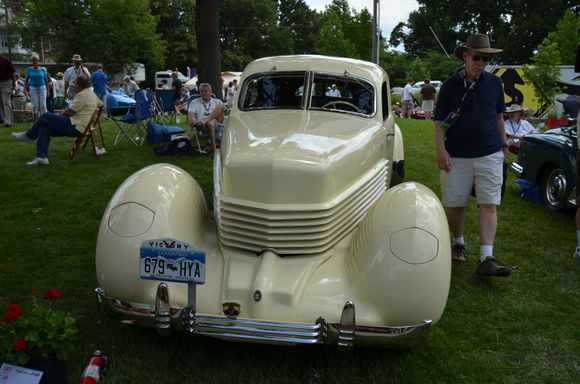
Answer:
[{"left": 435, "top": 71, "right": 505, "bottom": 158}]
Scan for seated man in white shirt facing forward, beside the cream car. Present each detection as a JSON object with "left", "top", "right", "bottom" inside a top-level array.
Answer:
[{"left": 187, "top": 83, "right": 225, "bottom": 152}]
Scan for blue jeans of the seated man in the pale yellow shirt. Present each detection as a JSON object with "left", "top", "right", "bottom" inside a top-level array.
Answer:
[{"left": 26, "top": 112, "right": 81, "bottom": 158}]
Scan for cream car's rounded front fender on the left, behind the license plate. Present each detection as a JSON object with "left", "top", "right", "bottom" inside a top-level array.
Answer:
[{"left": 96, "top": 164, "right": 222, "bottom": 303}]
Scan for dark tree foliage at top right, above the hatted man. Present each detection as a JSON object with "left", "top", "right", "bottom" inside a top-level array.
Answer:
[{"left": 390, "top": 0, "right": 580, "bottom": 64}]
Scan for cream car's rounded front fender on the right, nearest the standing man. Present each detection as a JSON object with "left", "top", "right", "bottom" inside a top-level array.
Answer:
[{"left": 348, "top": 182, "right": 451, "bottom": 324}]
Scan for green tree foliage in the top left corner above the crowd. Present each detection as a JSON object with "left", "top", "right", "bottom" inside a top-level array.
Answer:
[{"left": 14, "top": 0, "right": 165, "bottom": 72}]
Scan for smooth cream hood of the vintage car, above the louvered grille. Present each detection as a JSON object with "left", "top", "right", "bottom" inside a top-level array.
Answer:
[{"left": 221, "top": 110, "right": 386, "bottom": 206}]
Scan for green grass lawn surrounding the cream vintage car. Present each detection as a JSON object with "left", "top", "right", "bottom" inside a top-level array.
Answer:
[{"left": 0, "top": 120, "right": 580, "bottom": 384}]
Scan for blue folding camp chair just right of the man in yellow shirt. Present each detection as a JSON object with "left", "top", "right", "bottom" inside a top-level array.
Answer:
[{"left": 111, "top": 91, "right": 153, "bottom": 146}]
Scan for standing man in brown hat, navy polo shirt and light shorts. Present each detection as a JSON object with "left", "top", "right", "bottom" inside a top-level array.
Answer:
[{"left": 435, "top": 34, "right": 511, "bottom": 276}]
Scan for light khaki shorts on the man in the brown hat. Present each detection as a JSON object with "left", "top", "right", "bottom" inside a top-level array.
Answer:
[{"left": 441, "top": 151, "right": 504, "bottom": 208}]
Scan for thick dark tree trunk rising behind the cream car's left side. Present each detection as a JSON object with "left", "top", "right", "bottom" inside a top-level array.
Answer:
[{"left": 195, "top": 0, "right": 223, "bottom": 99}]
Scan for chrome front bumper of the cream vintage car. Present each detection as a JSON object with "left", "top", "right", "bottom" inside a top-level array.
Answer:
[{"left": 95, "top": 283, "right": 432, "bottom": 348}]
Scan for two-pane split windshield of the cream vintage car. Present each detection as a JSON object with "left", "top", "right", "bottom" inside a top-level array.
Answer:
[{"left": 240, "top": 72, "right": 375, "bottom": 116}]
